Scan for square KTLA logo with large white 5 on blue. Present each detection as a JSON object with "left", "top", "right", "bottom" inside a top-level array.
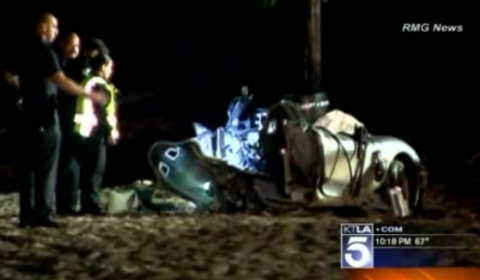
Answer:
[{"left": 341, "top": 224, "right": 374, "bottom": 268}]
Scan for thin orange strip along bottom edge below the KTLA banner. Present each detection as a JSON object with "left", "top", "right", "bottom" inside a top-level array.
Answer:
[{"left": 346, "top": 267, "right": 480, "bottom": 280}]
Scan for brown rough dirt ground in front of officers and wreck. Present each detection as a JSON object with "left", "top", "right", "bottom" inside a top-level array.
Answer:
[{"left": 0, "top": 183, "right": 480, "bottom": 280}]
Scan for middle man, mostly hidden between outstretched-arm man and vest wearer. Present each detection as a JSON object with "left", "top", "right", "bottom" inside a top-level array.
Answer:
[{"left": 56, "top": 32, "right": 80, "bottom": 215}]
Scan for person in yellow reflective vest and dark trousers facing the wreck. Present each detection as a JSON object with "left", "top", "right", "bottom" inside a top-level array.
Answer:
[{"left": 74, "top": 54, "right": 119, "bottom": 215}]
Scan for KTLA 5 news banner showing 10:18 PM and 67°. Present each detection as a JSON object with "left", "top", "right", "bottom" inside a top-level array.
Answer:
[{"left": 340, "top": 223, "right": 480, "bottom": 270}]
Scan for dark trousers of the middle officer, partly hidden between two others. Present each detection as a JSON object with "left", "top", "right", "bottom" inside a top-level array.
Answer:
[{"left": 56, "top": 121, "right": 80, "bottom": 214}]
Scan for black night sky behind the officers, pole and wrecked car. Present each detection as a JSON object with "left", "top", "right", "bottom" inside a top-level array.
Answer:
[{"left": 0, "top": 0, "right": 480, "bottom": 158}]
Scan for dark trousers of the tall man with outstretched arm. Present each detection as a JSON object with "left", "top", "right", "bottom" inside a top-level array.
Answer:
[{"left": 15, "top": 125, "right": 60, "bottom": 223}]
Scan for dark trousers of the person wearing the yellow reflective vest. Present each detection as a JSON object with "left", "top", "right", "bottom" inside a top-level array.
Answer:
[{"left": 75, "top": 135, "right": 107, "bottom": 214}]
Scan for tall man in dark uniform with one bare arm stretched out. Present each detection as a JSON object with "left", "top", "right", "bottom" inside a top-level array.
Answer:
[{"left": 5, "top": 13, "right": 105, "bottom": 227}]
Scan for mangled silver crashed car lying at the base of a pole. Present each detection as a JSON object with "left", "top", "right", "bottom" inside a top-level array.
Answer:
[{"left": 148, "top": 91, "right": 426, "bottom": 217}]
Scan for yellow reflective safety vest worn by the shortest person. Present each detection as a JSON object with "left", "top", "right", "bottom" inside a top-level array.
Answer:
[{"left": 74, "top": 76, "right": 120, "bottom": 140}]
